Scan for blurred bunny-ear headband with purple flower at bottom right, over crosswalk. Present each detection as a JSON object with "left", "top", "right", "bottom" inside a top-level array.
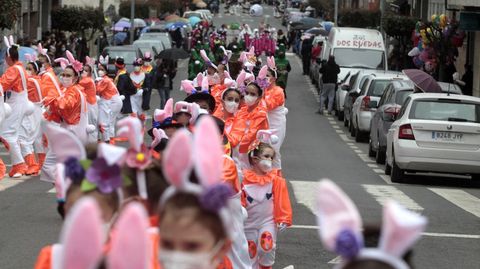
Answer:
[{"left": 316, "top": 179, "right": 427, "bottom": 269}]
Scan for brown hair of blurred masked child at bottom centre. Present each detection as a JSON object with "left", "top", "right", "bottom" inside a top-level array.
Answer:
[{"left": 159, "top": 192, "right": 227, "bottom": 242}]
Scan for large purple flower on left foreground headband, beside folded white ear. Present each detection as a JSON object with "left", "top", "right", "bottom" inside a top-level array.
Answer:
[{"left": 87, "top": 158, "right": 122, "bottom": 193}]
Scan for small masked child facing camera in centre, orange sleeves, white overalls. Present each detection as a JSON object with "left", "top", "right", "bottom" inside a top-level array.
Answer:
[{"left": 242, "top": 131, "right": 292, "bottom": 268}]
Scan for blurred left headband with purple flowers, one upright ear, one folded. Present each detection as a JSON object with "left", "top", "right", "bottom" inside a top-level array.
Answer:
[{"left": 43, "top": 123, "right": 129, "bottom": 201}]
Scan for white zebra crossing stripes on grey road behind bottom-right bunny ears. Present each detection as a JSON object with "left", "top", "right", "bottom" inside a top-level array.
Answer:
[{"left": 288, "top": 180, "right": 480, "bottom": 218}]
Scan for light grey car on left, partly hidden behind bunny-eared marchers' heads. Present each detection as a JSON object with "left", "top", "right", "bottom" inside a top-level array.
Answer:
[{"left": 102, "top": 45, "right": 142, "bottom": 77}]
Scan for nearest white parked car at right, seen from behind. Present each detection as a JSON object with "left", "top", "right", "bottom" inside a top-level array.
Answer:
[{"left": 385, "top": 93, "right": 480, "bottom": 182}]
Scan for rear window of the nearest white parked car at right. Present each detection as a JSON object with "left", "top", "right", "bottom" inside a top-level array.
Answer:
[{"left": 410, "top": 100, "right": 480, "bottom": 123}]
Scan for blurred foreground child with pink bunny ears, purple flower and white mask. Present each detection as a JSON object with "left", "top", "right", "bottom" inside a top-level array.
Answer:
[{"left": 159, "top": 117, "right": 239, "bottom": 269}]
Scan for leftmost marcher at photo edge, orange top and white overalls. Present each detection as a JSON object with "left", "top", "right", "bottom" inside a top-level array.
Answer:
[{"left": 0, "top": 36, "right": 33, "bottom": 177}]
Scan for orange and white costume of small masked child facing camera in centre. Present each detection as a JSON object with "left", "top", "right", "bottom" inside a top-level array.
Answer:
[{"left": 242, "top": 169, "right": 292, "bottom": 268}]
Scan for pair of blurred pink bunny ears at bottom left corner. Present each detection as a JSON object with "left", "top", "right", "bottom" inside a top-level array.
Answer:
[{"left": 58, "top": 197, "right": 151, "bottom": 269}]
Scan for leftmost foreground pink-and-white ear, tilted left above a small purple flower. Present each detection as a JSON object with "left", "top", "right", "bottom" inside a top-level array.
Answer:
[{"left": 43, "top": 123, "right": 87, "bottom": 163}]
